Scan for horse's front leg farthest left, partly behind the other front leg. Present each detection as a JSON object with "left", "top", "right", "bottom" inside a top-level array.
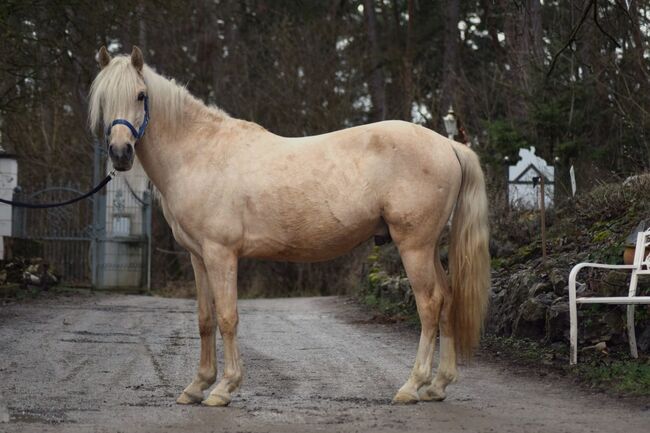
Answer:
[{"left": 176, "top": 254, "right": 217, "bottom": 404}]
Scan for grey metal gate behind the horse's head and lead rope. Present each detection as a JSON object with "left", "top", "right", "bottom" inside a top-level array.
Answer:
[{"left": 13, "top": 143, "right": 151, "bottom": 288}]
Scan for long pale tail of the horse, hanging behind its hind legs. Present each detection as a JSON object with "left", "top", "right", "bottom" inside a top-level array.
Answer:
[{"left": 449, "top": 143, "right": 490, "bottom": 359}]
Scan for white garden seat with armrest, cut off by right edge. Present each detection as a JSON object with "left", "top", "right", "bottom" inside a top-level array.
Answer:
[{"left": 569, "top": 229, "right": 650, "bottom": 364}]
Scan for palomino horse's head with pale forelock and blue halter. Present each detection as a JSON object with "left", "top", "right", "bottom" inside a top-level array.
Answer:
[{"left": 89, "top": 46, "right": 149, "bottom": 171}]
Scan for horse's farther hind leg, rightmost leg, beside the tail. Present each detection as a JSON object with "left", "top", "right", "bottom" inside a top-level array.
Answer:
[{"left": 418, "top": 255, "right": 458, "bottom": 401}]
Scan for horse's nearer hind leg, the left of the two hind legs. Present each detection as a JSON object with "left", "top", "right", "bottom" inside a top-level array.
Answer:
[{"left": 393, "top": 244, "right": 442, "bottom": 403}]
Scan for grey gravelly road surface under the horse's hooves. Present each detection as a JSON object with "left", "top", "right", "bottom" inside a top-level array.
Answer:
[{"left": 0, "top": 294, "right": 650, "bottom": 433}]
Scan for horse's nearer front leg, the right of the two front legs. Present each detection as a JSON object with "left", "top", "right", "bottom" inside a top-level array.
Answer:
[{"left": 203, "top": 246, "right": 243, "bottom": 406}]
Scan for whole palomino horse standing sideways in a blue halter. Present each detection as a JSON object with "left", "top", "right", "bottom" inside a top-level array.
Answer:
[{"left": 89, "top": 47, "right": 490, "bottom": 406}]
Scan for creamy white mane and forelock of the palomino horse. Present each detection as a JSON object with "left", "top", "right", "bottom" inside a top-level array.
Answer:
[{"left": 88, "top": 56, "right": 227, "bottom": 131}]
